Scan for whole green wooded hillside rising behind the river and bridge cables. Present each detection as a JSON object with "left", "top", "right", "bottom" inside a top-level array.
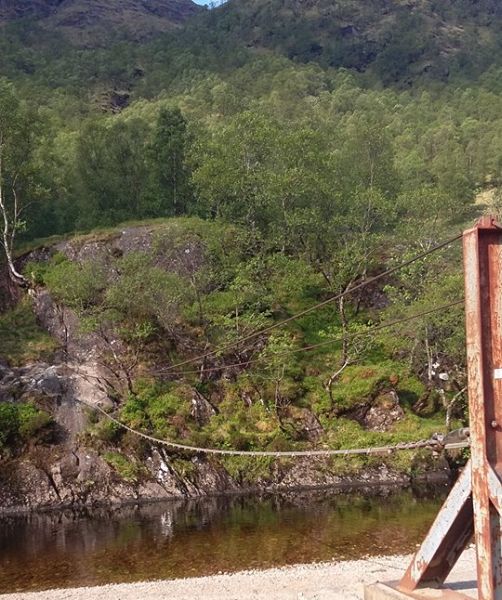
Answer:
[{"left": 0, "top": 0, "right": 494, "bottom": 506}]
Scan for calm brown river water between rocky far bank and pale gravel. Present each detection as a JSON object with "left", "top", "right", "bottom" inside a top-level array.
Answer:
[{"left": 0, "top": 491, "right": 446, "bottom": 593}]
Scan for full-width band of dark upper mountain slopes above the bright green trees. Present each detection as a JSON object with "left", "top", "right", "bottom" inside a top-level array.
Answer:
[{"left": 0, "top": 0, "right": 502, "bottom": 88}]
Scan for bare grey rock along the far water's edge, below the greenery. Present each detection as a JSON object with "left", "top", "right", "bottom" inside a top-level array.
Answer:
[{"left": 0, "top": 350, "right": 452, "bottom": 513}]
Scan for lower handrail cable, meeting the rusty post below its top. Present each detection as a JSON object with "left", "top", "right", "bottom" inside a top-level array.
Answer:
[{"left": 158, "top": 300, "right": 464, "bottom": 376}]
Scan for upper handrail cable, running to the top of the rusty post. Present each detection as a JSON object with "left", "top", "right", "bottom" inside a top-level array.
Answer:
[{"left": 163, "top": 233, "right": 462, "bottom": 372}]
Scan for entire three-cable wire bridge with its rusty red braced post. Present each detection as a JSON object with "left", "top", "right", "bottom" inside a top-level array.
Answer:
[{"left": 78, "top": 217, "right": 502, "bottom": 600}]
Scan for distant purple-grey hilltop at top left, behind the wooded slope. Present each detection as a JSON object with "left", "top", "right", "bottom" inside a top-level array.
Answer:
[{"left": 0, "top": 0, "right": 201, "bottom": 45}]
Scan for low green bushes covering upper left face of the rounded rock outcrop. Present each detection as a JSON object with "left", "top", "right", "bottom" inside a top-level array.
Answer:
[{"left": 30, "top": 243, "right": 188, "bottom": 347}]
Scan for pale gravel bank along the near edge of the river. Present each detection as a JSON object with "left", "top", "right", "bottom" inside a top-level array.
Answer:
[{"left": 0, "top": 548, "right": 475, "bottom": 600}]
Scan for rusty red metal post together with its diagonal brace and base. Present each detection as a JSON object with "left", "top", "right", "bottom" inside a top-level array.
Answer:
[{"left": 366, "top": 217, "right": 502, "bottom": 600}]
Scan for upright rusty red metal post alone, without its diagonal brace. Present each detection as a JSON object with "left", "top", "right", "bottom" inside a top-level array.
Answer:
[{"left": 464, "top": 217, "right": 502, "bottom": 600}]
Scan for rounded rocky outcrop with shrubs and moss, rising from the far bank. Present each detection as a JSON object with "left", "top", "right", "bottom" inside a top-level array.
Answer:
[{"left": 0, "top": 219, "right": 461, "bottom": 510}]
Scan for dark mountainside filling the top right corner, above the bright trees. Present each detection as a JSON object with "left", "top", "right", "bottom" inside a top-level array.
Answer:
[{"left": 195, "top": 0, "right": 502, "bottom": 83}]
